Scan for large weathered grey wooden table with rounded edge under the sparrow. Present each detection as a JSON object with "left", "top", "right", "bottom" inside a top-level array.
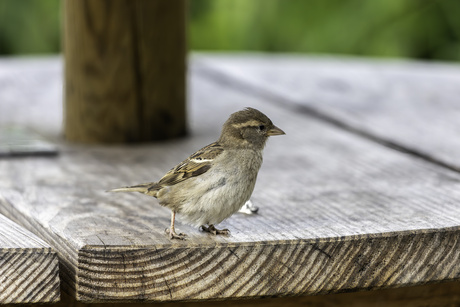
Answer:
[{"left": 0, "top": 54, "right": 460, "bottom": 306}]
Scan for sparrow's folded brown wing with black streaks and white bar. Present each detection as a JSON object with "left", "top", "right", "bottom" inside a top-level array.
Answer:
[{"left": 158, "top": 143, "right": 224, "bottom": 186}]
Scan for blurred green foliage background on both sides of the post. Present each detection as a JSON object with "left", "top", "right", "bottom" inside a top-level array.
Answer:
[{"left": 0, "top": 0, "right": 460, "bottom": 61}]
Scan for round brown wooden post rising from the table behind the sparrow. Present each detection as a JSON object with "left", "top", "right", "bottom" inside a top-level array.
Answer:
[{"left": 64, "top": 0, "right": 186, "bottom": 143}]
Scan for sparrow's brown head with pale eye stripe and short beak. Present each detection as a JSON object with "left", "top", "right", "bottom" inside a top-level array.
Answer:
[{"left": 219, "top": 108, "right": 285, "bottom": 149}]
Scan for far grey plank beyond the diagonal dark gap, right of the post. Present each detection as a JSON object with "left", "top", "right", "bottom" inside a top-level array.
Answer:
[{"left": 196, "top": 54, "right": 460, "bottom": 170}]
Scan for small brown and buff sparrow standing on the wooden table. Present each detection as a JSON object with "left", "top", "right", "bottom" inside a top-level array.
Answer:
[{"left": 108, "top": 108, "right": 285, "bottom": 239}]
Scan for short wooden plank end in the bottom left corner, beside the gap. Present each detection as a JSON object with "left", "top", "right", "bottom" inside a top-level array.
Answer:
[{"left": 0, "top": 215, "right": 60, "bottom": 304}]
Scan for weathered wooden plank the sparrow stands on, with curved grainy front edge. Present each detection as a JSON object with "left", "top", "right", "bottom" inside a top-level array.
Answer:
[{"left": 0, "top": 57, "right": 460, "bottom": 302}]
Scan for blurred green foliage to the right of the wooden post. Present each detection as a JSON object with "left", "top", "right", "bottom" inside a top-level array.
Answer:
[{"left": 190, "top": 0, "right": 460, "bottom": 60}]
